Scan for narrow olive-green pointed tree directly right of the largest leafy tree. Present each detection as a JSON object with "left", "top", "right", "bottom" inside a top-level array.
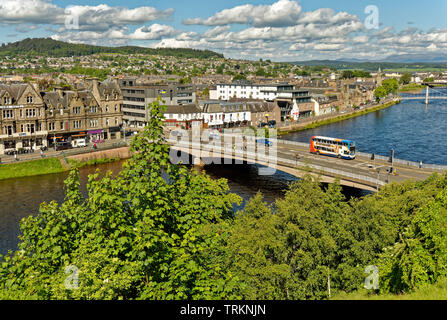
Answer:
[{"left": 228, "top": 193, "right": 290, "bottom": 300}]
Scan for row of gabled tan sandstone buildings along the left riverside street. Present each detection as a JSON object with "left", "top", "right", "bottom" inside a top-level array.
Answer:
[{"left": 0, "top": 81, "right": 122, "bottom": 154}]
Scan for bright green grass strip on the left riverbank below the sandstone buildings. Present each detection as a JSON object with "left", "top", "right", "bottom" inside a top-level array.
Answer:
[{"left": 0, "top": 158, "right": 65, "bottom": 180}]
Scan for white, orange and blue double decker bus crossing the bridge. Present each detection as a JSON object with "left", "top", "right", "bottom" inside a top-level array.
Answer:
[{"left": 310, "top": 136, "right": 355, "bottom": 160}]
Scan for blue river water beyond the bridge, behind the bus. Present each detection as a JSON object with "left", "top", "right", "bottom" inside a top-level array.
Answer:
[{"left": 283, "top": 88, "right": 447, "bottom": 165}]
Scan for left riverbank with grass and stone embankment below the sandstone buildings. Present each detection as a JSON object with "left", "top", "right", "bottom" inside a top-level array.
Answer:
[{"left": 0, "top": 147, "right": 130, "bottom": 181}]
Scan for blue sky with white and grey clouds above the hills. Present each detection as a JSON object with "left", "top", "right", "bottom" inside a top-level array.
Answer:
[{"left": 0, "top": 0, "right": 447, "bottom": 61}]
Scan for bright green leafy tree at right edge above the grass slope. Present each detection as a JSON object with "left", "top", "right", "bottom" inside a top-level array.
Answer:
[{"left": 381, "top": 189, "right": 447, "bottom": 293}]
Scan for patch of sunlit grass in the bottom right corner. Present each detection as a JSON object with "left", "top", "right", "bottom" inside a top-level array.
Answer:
[{"left": 332, "top": 278, "right": 447, "bottom": 300}]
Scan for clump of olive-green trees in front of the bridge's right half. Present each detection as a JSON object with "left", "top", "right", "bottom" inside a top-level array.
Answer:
[{"left": 228, "top": 175, "right": 447, "bottom": 299}]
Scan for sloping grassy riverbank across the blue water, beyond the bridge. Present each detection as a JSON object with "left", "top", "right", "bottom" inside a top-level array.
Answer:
[{"left": 278, "top": 100, "right": 400, "bottom": 136}]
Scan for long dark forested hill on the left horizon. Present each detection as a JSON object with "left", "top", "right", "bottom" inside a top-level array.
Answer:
[{"left": 0, "top": 38, "right": 224, "bottom": 59}]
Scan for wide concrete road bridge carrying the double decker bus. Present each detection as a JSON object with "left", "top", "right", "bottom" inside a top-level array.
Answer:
[{"left": 168, "top": 135, "right": 447, "bottom": 192}]
